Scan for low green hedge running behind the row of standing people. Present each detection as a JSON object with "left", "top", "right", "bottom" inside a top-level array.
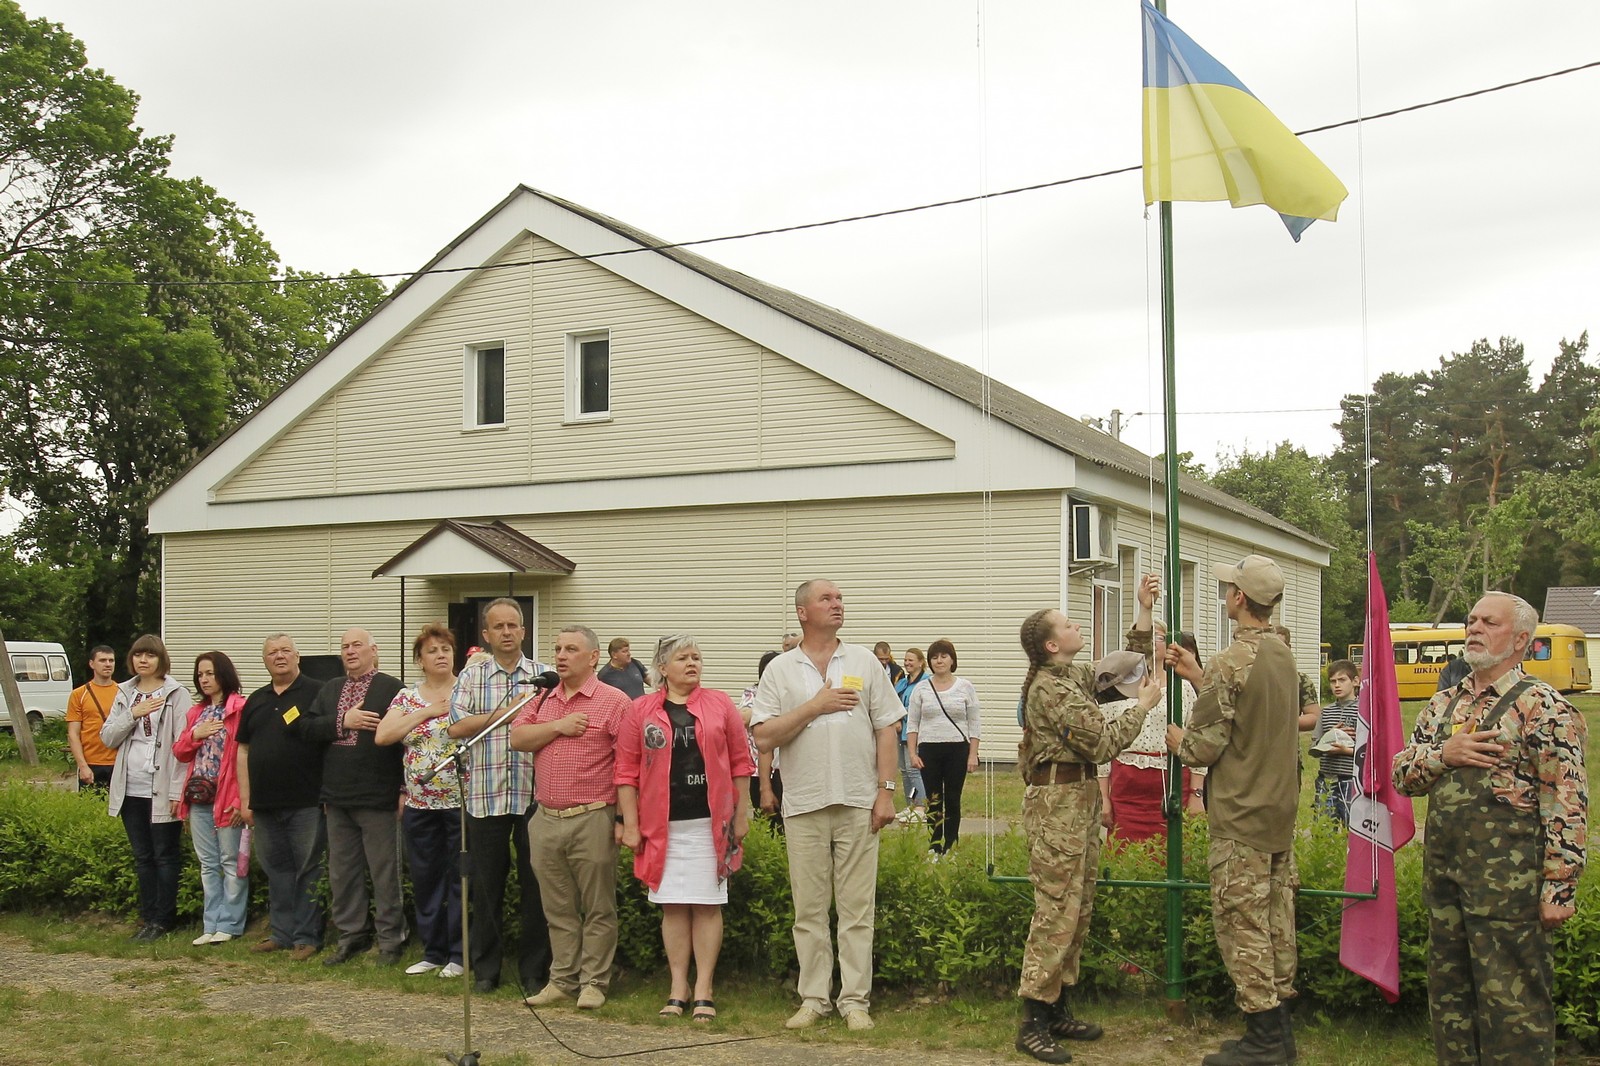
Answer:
[{"left": 0, "top": 771, "right": 1600, "bottom": 1040}]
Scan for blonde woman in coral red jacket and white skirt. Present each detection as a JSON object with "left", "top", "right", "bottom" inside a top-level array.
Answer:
[{"left": 616, "top": 634, "right": 755, "bottom": 1021}]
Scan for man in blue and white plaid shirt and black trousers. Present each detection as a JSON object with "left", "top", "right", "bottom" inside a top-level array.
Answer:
[{"left": 450, "top": 597, "right": 550, "bottom": 992}]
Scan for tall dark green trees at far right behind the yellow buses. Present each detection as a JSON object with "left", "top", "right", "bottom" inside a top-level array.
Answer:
[{"left": 1330, "top": 333, "right": 1600, "bottom": 623}]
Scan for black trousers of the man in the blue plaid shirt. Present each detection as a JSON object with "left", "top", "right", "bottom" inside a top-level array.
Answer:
[{"left": 467, "top": 804, "right": 550, "bottom": 996}]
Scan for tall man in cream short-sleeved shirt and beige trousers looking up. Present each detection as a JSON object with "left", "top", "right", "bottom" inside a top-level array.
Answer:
[{"left": 750, "top": 581, "right": 906, "bottom": 1029}]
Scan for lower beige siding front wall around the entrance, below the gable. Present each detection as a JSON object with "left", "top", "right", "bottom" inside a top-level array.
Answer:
[{"left": 166, "top": 493, "right": 1061, "bottom": 759}]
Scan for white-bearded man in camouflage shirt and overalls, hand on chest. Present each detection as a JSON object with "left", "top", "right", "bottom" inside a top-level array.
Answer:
[{"left": 1394, "top": 592, "right": 1589, "bottom": 1063}]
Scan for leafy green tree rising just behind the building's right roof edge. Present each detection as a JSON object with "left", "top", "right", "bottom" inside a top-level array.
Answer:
[{"left": 1211, "top": 442, "right": 1366, "bottom": 648}]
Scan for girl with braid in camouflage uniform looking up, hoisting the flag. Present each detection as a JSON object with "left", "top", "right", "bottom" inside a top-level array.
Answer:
[{"left": 1016, "top": 610, "right": 1162, "bottom": 1063}]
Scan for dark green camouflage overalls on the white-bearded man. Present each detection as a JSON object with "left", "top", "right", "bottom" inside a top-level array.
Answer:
[{"left": 1422, "top": 758, "right": 1555, "bottom": 1064}]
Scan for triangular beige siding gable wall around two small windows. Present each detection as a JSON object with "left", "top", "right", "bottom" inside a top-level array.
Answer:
[{"left": 218, "top": 237, "right": 954, "bottom": 501}]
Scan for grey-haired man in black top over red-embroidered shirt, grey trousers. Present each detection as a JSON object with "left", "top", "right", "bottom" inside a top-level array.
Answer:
[{"left": 291, "top": 627, "right": 405, "bottom": 967}]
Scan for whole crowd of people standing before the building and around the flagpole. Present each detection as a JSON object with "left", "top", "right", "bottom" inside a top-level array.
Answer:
[{"left": 69, "top": 569, "right": 1587, "bottom": 1066}]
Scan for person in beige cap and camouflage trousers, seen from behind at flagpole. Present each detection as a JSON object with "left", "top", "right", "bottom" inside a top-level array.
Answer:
[{"left": 1166, "top": 555, "right": 1301, "bottom": 1066}]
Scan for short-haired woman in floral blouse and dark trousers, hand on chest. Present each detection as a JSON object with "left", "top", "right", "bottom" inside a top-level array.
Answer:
[{"left": 373, "top": 623, "right": 461, "bottom": 976}]
